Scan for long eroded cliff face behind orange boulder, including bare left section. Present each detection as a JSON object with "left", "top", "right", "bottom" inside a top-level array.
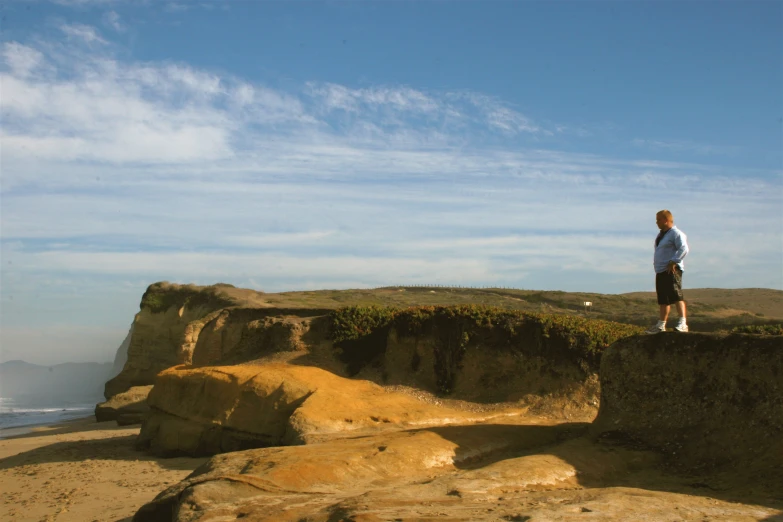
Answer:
[{"left": 192, "top": 309, "right": 599, "bottom": 408}]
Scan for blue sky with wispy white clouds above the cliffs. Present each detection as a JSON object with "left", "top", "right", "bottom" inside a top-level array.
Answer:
[{"left": 0, "top": 0, "right": 783, "bottom": 364}]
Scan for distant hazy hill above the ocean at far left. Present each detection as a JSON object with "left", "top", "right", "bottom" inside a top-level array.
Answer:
[{"left": 0, "top": 360, "right": 112, "bottom": 400}]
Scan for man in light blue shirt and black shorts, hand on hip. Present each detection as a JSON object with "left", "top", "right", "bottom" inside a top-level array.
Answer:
[{"left": 647, "top": 210, "right": 688, "bottom": 334}]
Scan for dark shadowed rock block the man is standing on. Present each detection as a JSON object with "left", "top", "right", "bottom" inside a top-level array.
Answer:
[{"left": 592, "top": 333, "right": 783, "bottom": 480}]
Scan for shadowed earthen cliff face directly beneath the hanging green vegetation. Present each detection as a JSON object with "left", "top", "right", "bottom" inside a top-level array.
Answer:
[{"left": 368, "top": 328, "right": 600, "bottom": 410}]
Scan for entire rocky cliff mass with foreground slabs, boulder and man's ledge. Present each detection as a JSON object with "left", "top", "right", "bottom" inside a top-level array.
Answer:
[{"left": 98, "top": 285, "right": 783, "bottom": 522}]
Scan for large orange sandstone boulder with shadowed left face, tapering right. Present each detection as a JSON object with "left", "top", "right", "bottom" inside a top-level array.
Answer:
[{"left": 138, "top": 363, "right": 525, "bottom": 455}]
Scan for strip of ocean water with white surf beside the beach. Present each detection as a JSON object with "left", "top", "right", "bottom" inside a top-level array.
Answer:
[{"left": 0, "top": 397, "right": 100, "bottom": 432}]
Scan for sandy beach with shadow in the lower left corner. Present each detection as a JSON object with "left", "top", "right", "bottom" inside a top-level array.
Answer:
[{"left": 0, "top": 417, "right": 206, "bottom": 522}]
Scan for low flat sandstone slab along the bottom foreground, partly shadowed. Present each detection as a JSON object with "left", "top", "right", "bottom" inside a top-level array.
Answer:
[{"left": 134, "top": 424, "right": 781, "bottom": 522}]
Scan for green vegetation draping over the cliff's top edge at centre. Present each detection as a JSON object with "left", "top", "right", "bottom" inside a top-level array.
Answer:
[{"left": 329, "top": 305, "right": 642, "bottom": 393}]
